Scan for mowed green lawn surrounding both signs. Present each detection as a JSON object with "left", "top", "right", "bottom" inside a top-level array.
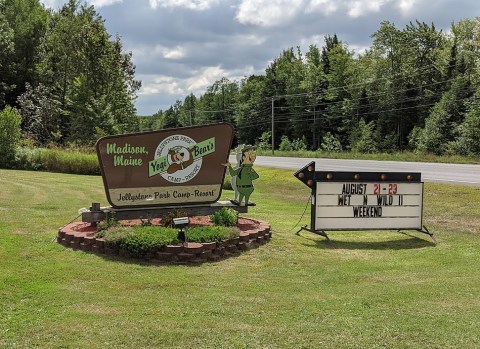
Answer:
[{"left": 0, "top": 168, "right": 480, "bottom": 349}]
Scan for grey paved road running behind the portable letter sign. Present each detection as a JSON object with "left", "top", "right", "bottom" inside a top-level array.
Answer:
[{"left": 230, "top": 156, "right": 480, "bottom": 187}]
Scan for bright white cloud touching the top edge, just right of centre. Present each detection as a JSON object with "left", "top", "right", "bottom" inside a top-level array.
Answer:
[{"left": 235, "top": 0, "right": 303, "bottom": 27}]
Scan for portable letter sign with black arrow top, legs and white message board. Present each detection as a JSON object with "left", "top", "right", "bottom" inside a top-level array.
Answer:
[{"left": 295, "top": 162, "right": 433, "bottom": 239}]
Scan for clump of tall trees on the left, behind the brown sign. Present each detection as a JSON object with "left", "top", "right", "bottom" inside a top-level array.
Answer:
[{"left": 0, "top": 0, "right": 140, "bottom": 146}]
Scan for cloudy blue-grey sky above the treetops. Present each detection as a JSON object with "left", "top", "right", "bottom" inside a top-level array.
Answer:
[{"left": 41, "top": 0, "right": 480, "bottom": 115}]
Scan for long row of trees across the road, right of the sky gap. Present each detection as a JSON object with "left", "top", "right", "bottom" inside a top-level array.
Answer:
[{"left": 141, "top": 18, "right": 480, "bottom": 155}]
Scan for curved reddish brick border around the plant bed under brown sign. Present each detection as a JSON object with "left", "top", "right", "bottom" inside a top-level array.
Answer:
[{"left": 57, "top": 218, "right": 272, "bottom": 264}]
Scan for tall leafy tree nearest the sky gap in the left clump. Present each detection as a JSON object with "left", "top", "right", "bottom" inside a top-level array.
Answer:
[{"left": 36, "top": 0, "right": 140, "bottom": 144}]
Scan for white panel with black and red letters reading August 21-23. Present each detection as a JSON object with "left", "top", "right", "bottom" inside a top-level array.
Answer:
[{"left": 315, "top": 180, "right": 423, "bottom": 230}]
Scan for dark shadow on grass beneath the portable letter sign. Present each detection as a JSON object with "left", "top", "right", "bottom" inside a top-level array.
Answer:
[{"left": 298, "top": 232, "right": 436, "bottom": 250}]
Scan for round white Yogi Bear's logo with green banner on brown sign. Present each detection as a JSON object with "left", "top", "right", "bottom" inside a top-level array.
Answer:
[{"left": 148, "top": 135, "right": 215, "bottom": 183}]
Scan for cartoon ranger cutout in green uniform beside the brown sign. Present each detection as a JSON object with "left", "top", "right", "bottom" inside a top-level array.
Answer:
[{"left": 224, "top": 146, "right": 259, "bottom": 206}]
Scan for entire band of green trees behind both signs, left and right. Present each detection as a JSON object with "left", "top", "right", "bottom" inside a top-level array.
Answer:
[{"left": 0, "top": 0, "right": 480, "bottom": 155}]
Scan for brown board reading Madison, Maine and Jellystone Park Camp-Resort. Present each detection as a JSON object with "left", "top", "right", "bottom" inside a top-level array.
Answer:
[{"left": 96, "top": 124, "right": 233, "bottom": 208}]
